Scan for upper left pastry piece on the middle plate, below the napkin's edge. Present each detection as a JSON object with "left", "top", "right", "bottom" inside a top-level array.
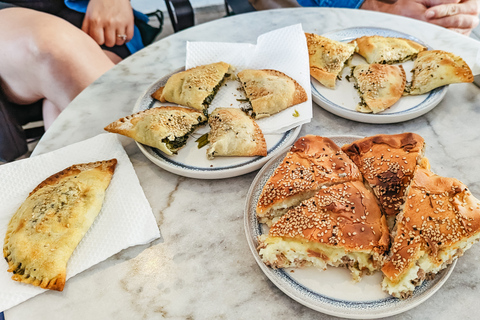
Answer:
[{"left": 152, "top": 62, "right": 231, "bottom": 111}]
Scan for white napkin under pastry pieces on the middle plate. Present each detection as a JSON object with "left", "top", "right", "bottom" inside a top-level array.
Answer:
[{"left": 185, "top": 24, "right": 312, "bottom": 134}]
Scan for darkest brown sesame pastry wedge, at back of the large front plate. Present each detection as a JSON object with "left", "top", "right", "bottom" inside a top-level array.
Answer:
[{"left": 342, "top": 132, "right": 429, "bottom": 227}]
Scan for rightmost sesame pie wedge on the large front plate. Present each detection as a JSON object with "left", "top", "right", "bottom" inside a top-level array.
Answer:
[{"left": 382, "top": 168, "right": 480, "bottom": 298}]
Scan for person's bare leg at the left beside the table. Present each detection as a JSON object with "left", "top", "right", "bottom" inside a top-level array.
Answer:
[{"left": 0, "top": 8, "right": 114, "bottom": 127}]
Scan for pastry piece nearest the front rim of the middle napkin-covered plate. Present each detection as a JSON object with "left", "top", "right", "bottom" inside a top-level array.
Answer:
[{"left": 207, "top": 108, "right": 267, "bottom": 159}]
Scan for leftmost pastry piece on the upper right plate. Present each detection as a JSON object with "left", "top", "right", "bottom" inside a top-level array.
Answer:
[{"left": 305, "top": 33, "right": 356, "bottom": 89}]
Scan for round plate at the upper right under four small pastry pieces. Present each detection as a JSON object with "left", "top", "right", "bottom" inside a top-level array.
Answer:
[{"left": 311, "top": 27, "right": 448, "bottom": 123}]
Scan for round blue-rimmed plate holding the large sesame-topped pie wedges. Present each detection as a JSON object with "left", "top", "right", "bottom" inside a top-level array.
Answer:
[{"left": 244, "top": 136, "right": 456, "bottom": 319}]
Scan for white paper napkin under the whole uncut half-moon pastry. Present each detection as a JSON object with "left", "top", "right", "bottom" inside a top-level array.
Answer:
[{"left": 0, "top": 133, "right": 160, "bottom": 311}]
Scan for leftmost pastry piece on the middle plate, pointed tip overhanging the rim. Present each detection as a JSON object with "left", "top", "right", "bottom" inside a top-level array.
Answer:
[{"left": 105, "top": 107, "right": 207, "bottom": 155}]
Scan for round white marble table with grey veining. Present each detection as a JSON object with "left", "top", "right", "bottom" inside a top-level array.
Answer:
[{"left": 5, "top": 8, "right": 480, "bottom": 320}]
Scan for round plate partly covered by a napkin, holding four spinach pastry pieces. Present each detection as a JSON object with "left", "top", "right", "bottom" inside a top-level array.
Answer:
[{"left": 133, "top": 68, "right": 301, "bottom": 179}]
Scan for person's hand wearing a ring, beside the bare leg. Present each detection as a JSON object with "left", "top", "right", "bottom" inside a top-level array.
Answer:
[{"left": 82, "top": 0, "right": 134, "bottom": 47}]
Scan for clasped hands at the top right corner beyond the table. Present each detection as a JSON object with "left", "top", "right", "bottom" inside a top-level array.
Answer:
[{"left": 425, "top": 0, "right": 480, "bottom": 35}]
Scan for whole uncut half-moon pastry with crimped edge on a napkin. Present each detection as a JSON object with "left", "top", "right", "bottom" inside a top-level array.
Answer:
[{"left": 3, "top": 159, "right": 117, "bottom": 291}]
